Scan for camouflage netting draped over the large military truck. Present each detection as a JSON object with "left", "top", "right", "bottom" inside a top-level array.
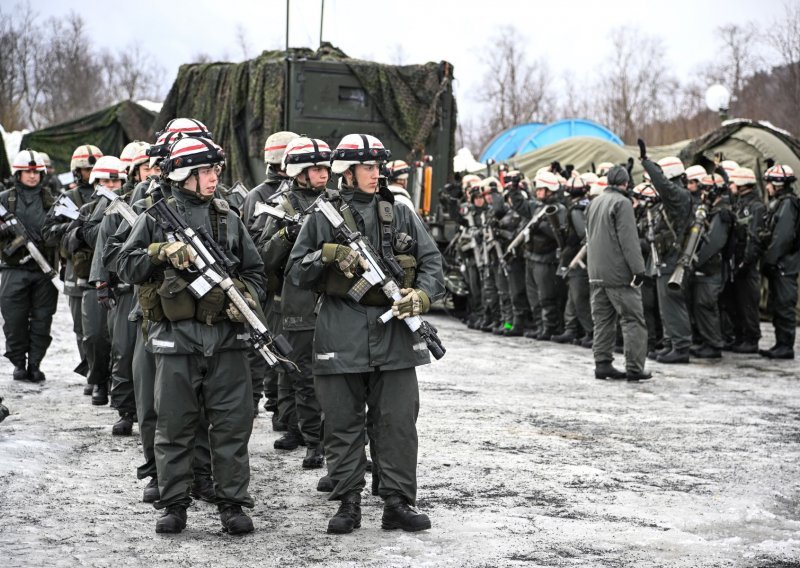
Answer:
[{"left": 155, "top": 43, "right": 455, "bottom": 187}]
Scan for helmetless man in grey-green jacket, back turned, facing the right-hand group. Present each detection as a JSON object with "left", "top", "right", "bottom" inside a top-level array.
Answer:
[{"left": 586, "top": 166, "right": 652, "bottom": 381}]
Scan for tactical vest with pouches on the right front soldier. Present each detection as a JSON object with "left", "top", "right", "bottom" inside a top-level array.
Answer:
[{"left": 318, "top": 191, "right": 417, "bottom": 306}]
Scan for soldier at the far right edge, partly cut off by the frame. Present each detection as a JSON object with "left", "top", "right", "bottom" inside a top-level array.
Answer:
[{"left": 758, "top": 165, "right": 800, "bottom": 359}]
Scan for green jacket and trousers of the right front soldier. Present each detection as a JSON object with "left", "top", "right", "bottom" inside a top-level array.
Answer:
[{"left": 286, "top": 187, "right": 444, "bottom": 504}]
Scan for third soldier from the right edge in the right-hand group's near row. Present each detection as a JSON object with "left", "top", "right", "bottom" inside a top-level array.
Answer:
[{"left": 689, "top": 174, "right": 734, "bottom": 359}]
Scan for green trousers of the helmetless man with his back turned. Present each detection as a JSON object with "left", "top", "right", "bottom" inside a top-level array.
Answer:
[{"left": 591, "top": 285, "right": 647, "bottom": 373}]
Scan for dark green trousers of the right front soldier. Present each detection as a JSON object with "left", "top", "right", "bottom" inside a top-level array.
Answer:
[{"left": 314, "top": 367, "right": 419, "bottom": 504}]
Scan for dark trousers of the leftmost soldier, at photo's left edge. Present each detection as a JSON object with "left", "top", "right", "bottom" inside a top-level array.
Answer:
[{"left": 0, "top": 268, "right": 58, "bottom": 367}]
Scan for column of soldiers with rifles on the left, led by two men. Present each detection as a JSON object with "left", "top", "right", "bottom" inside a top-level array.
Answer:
[{"left": 0, "top": 123, "right": 444, "bottom": 534}]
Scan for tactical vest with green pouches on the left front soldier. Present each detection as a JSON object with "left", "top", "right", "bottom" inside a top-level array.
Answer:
[{"left": 137, "top": 197, "right": 234, "bottom": 325}]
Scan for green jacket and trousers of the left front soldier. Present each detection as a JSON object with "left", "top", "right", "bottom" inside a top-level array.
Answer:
[{"left": 117, "top": 189, "right": 263, "bottom": 508}]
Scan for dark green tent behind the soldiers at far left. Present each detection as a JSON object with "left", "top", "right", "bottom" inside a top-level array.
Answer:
[{"left": 20, "top": 101, "right": 155, "bottom": 172}]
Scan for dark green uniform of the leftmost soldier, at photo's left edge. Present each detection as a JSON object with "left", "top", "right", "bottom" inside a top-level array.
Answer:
[{"left": 0, "top": 182, "right": 58, "bottom": 368}]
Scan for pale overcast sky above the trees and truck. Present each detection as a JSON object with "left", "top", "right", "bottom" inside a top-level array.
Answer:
[{"left": 34, "top": 0, "right": 784, "bottom": 123}]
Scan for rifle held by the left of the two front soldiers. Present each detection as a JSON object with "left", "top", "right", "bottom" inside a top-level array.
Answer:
[{"left": 146, "top": 199, "right": 297, "bottom": 372}]
